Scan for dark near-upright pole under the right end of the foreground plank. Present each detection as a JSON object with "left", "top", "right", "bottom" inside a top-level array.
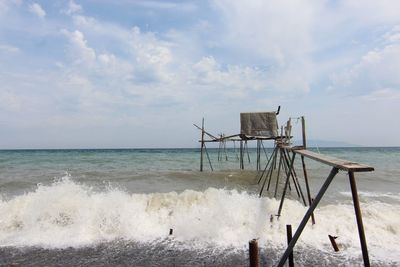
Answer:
[{"left": 349, "top": 171, "right": 370, "bottom": 267}]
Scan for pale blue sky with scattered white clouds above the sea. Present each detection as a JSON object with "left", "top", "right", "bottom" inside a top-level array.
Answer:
[{"left": 0, "top": 0, "right": 400, "bottom": 149}]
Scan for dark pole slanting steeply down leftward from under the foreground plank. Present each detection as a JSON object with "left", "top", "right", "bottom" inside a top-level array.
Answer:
[{"left": 277, "top": 167, "right": 339, "bottom": 267}]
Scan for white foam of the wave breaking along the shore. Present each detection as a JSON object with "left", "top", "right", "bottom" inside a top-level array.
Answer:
[{"left": 0, "top": 177, "right": 400, "bottom": 263}]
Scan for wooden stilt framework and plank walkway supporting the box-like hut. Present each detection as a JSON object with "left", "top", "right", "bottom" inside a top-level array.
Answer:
[{"left": 194, "top": 112, "right": 374, "bottom": 267}]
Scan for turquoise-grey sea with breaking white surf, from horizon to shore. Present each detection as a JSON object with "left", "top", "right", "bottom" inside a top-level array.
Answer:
[{"left": 0, "top": 148, "right": 400, "bottom": 266}]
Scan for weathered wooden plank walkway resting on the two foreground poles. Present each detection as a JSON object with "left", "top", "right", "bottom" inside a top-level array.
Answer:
[{"left": 290, "top": 148, "right": 374, "bottom": 172}]
